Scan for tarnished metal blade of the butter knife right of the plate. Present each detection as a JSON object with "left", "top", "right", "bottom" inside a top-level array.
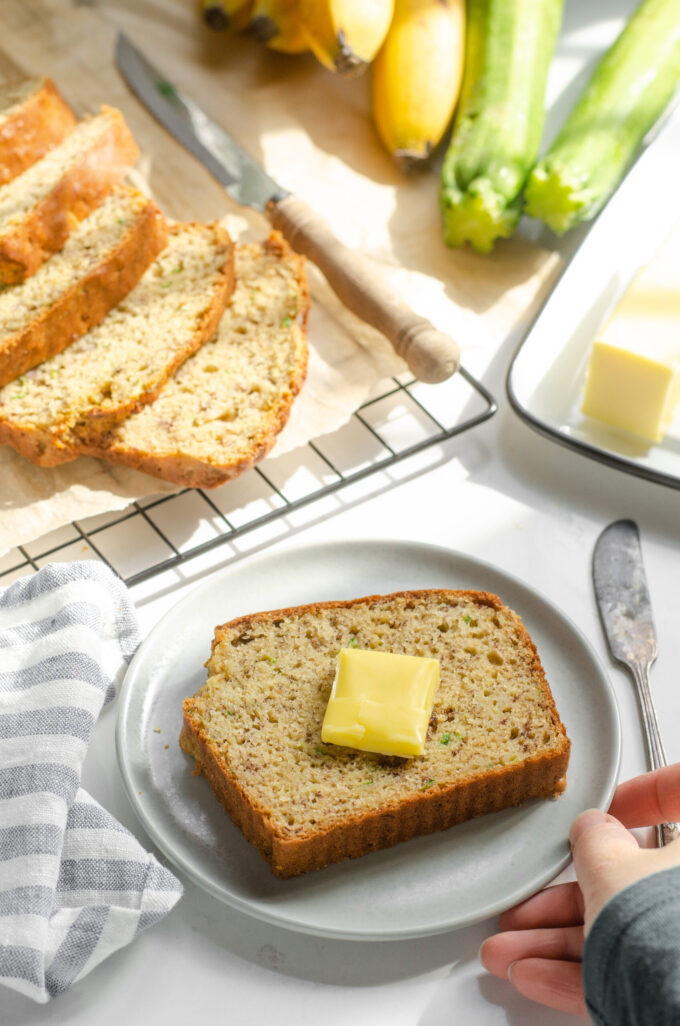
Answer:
[{"left": 593, "top": 520, "right": 656, "bottom": 666}]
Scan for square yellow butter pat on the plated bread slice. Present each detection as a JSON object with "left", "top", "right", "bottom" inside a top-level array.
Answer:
[{"left": 321, "top": 648, "right": 439, "bottom": 756}]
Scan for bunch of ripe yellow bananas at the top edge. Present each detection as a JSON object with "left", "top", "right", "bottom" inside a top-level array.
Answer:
[{"left": 200, "top": 0, "right": 466, "bottom": 169}]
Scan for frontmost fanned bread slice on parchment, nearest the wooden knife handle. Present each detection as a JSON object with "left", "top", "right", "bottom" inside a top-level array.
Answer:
[{"left": 91, "top": 233, "right": 309, "bottom": 487}]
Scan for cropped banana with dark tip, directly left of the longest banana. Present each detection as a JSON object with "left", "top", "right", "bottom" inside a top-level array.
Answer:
[{"left": 299, "top": 0, "right": 394, "bottom": 75}]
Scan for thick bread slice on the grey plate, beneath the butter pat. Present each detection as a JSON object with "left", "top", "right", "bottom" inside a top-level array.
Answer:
[{"left": 179, "top": 590, "right": 570, "bottom": 878}]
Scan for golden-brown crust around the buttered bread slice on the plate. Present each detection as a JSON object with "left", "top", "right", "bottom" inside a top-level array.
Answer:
[{"left": 179, "top": 590, "right": 570, "bottom": 878}]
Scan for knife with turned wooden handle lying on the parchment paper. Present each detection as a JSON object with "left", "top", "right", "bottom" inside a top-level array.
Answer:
[{"left": 116, "top": 33, "right": 461, "bottom": 383}]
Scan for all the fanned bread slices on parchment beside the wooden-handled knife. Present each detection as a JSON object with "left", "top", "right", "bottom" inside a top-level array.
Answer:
[{"left": 0, "top": 79, "right": 309, "bottom": 487}]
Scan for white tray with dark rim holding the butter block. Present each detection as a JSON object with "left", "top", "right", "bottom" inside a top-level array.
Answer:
[{"left": 507, "top": 109, "right": 680, "bottom": 487}]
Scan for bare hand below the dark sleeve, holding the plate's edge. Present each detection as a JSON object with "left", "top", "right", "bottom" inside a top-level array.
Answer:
[{"left": 480, "top": 763, "right": 680, "bottom": 1015}]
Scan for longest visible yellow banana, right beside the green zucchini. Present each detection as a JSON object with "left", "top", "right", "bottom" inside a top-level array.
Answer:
[{"left": 372, "top": 0, "right": 465, "bottom": 170}]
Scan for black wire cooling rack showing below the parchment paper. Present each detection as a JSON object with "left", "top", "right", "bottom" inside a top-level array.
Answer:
[{"left": 0, "top": 367, "right": 496, "bottom": 585}]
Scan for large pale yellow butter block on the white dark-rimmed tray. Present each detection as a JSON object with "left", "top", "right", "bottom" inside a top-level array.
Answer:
[{"left": 582, "top": 235, "right": 680, "bottom": 442}]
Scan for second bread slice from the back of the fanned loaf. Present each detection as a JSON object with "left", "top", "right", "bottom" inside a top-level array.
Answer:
[{"left": 0, "top": 107, "right": 138, "bottom": 285}]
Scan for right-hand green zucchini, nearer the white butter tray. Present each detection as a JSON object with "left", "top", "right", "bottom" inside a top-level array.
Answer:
[{"left": 525, "top": 0, "right": 680, "bottom": 235}]
